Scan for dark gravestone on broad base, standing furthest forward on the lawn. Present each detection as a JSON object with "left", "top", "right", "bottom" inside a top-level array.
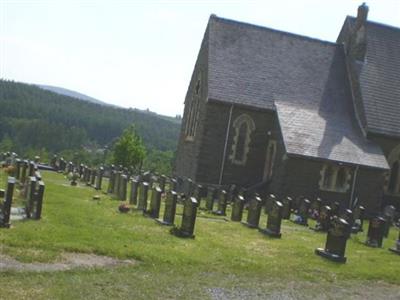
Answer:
[{"left": 315, "top": 217, "right": 350, "bottom": 263}]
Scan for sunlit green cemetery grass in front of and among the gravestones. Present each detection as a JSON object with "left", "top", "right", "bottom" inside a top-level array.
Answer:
[{"left": 0, "top": 171, "right": 400, "bottom": 299}]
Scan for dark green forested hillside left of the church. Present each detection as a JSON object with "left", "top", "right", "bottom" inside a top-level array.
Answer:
[{"left": 0, "top": 80, "right": 179, "bottom": 159}]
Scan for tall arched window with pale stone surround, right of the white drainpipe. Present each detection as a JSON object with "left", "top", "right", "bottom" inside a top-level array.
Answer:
[{"left": 229, "top": 114, "right": 256, "bottom": 165}]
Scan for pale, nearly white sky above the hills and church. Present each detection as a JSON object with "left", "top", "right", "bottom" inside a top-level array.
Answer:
[{"left": 0, "top": 0, "right": 400, "bottom": 116}]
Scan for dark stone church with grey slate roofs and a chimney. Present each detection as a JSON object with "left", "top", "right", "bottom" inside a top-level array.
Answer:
[{"left": 175, "top": 4, "right": 400, "bottom": 213}]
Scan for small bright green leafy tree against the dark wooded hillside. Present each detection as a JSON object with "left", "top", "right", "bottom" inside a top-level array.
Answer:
[{"left": 113, "top": 126, "right": 146, "bottom": 168}]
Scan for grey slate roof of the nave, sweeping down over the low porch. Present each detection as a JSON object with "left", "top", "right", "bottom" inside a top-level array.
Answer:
[{"left": 208, "top": 16, "right": 388, "bottom": 169}]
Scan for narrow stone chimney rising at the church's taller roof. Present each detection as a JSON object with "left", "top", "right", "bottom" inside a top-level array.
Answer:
[{"left": 350, "top": 2, "right": 368, "bottom": 62}]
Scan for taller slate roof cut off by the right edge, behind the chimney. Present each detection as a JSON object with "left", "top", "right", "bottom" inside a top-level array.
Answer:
[{"left": 347, "top": 17, "right": 400, "bottom": 137}]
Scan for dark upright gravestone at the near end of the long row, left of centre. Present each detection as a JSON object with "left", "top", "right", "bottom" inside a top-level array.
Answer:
[{"left": 171, "top": 197, "right": 197, "bottom": 238}]
